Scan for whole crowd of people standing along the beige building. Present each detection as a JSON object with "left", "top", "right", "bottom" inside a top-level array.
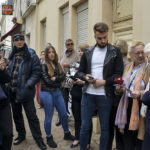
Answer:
[{"left": 0, "top": 22, "right": 150, "bottom": 150}]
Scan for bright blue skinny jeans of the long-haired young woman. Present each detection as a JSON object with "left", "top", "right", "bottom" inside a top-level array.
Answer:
[{"left": 40, "top": 88, "right": 69, "bottom": 137}]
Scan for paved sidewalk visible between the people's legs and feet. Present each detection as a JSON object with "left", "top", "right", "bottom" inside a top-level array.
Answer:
[{"left": 12, "top": 102, "right": 98, "bottom": 150}]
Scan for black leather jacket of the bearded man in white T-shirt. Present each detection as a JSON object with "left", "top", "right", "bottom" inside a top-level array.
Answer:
[{"left": 78, "top": 44, "right": 124, "bottom": 97}]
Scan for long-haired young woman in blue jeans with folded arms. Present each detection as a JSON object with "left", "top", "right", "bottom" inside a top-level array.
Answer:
[{"left": 40, "top": 46, "right": 74, "bottom": 148}]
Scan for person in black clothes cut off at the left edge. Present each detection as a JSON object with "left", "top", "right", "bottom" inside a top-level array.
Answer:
[{"left": 0, "top": 58, "right": 13, "bottom": 150}]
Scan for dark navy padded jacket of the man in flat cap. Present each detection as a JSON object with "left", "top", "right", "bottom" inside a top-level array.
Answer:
[{"left": 8, "top": 44, "right": 41, "bottom": 102}]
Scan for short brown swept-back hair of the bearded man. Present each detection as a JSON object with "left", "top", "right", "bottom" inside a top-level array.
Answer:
[{"left": 93, "top": 22, "right": 109, "bottom": 33}]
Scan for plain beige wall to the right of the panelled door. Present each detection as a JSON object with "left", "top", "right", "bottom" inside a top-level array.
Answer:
[{"left": 133, "top": 0, "right": 150, "bottom": 43}]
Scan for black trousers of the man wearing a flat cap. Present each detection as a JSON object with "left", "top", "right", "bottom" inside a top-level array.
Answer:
[{"left": 12, "top": 100, "right": 41, "bottom": 140}]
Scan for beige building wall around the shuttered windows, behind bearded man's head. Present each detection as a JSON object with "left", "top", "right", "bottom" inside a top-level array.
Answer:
[{"left": 36, "top": 0, "right": 112, "bottom": 54}]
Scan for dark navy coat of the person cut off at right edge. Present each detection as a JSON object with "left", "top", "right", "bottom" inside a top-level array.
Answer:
[{"left": 142, "top": 91, "right": 150, "bottom": 134}]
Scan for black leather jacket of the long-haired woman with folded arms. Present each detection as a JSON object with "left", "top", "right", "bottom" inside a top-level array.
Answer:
[{"left": 41, "top": 64, "right": 65, "bottom": 92}]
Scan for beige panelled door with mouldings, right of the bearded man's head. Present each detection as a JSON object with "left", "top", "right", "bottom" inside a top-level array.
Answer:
[{"left": 112, "top": 0, "right": 133, "bottom": 44}]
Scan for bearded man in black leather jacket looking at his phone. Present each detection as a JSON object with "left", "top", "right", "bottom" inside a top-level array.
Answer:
[{"left": 78, "top": 23, "right": 123, "bottom": 150}]
